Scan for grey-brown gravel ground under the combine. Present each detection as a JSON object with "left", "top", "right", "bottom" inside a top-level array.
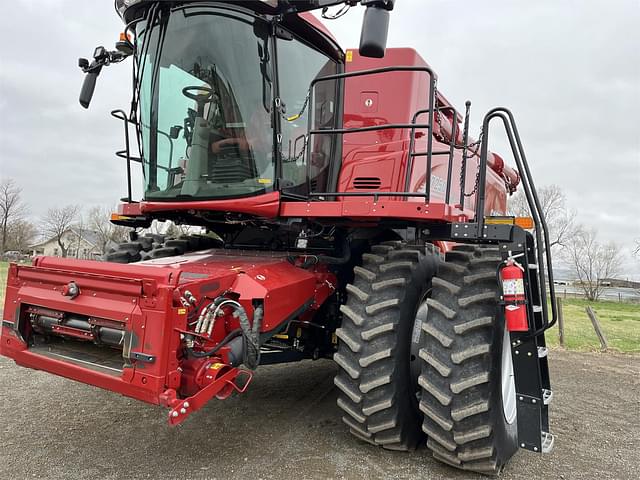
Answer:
[{"left": 0, "top": 351, "right": 640, "bottom": 480}]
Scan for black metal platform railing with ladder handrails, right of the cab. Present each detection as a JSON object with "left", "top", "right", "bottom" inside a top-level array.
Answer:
[{"left": 306, "top": 66, "right": 557, "bottom": 335}]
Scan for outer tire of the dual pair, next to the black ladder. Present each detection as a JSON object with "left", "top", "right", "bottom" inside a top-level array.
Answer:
[{"left": 419, "top": 245, "right": 518, "bottom": 474}]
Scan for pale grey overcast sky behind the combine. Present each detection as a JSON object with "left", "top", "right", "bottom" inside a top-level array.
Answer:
[{"left": 0, "top": 0, "right": 640, "bottom": 273}]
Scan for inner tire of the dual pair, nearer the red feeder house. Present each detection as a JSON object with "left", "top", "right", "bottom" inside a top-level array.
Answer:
[{"left": 334, "top": 242, "right": 436, "bottom": 450}]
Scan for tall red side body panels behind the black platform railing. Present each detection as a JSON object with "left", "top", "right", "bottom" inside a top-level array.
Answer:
[{"left": 338, "top": 48, "right": 506, "bottom": 216}]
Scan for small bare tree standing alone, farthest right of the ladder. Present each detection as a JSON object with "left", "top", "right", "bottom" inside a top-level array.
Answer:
[{"left": 564, "top": 227, "right": 622, "bottom": 301}]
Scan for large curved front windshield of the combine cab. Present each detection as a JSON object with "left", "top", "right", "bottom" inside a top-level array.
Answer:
[{"left": 136, "top": 7, "right": 275, "bottom": 200}]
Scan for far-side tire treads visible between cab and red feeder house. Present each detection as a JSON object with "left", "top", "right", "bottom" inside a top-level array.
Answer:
[{"left": 103, "top": 233, "right": 221, "bottom": 263}]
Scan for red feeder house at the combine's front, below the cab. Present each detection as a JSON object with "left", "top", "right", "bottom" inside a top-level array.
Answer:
[{"left": 0, "top": 250, "right": 336, "bottom": 403}]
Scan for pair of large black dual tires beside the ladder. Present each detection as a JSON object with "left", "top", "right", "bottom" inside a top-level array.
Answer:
[{"left": 334, "top": 242, "right": 517, "bottom": 474}]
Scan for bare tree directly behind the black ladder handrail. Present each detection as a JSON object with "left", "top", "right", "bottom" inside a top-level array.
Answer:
[{"left": 509, "top": 185, "right": 576, "bottom": 248}]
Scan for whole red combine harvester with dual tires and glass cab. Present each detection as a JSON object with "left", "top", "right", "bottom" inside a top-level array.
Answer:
[{"left": 0, "top": 0, "right": 556, "bottom": 474}]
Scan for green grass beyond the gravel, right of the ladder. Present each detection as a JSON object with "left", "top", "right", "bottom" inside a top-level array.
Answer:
[{"left": 546, "top": 299, "right": 640, "bottom": 353}]
